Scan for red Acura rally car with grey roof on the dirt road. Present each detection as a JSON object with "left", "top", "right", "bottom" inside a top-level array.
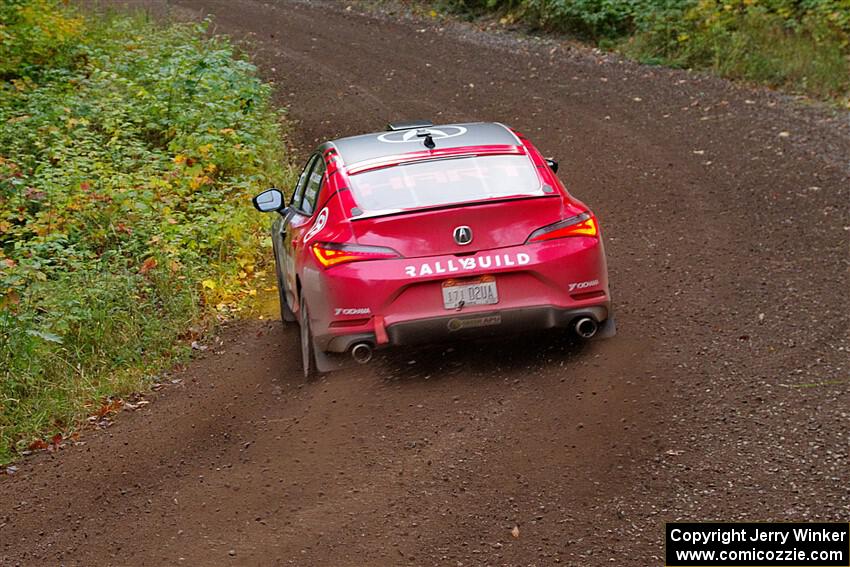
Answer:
[{"left": 248, "top": 122, "right": 615, "bottom": 376}]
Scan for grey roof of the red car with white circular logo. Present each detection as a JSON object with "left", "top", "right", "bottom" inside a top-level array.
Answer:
[{"left": 328, "top": 122, "right": 522, "bottom": 166}]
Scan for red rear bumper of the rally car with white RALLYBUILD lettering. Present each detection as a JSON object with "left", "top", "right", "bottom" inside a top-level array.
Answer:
[{"left": 302, "top": 237, "right": 611, "bottom": 352}]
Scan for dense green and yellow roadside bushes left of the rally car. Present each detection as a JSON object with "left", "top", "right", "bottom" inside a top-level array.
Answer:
[{"left": 0, "top": 0, "right": 289, "bottom": 463}]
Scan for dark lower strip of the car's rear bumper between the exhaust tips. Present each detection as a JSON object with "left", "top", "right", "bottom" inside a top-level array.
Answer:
[{"left": 326, "top": 303, "right": 610, "bottom": 352}]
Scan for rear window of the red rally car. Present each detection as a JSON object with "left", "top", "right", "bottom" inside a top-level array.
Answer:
[{"left": 351, "top": 155, "right": 544, "bottom": 212}]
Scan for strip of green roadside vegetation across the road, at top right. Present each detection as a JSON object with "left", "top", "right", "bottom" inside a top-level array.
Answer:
[{"left": 431, "top": 0, "right": 850, "bottom": 105}]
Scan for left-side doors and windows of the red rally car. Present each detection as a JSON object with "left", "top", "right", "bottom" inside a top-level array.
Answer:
[{"left": 281, "top": 154, "right": 326, "bottom": 310}]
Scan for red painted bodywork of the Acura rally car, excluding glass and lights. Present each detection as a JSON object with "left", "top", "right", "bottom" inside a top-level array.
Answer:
[{"left": 264, "top": 125, "right": 610, "bottom": 358}]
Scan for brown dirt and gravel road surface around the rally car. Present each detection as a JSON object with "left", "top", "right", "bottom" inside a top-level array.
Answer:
[{"left": 0, "top": 0, "right": 850, "bottom": 567}]
